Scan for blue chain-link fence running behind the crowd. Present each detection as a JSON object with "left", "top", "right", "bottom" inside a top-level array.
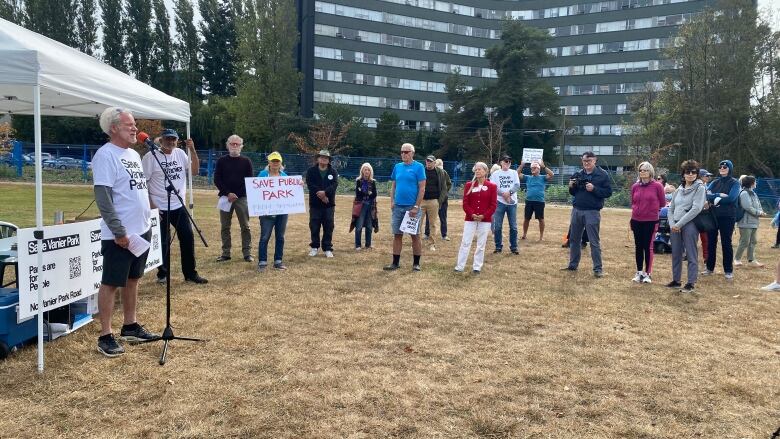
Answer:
[{"left": 0, "top": 142, "right": 780, "bottom": 212}]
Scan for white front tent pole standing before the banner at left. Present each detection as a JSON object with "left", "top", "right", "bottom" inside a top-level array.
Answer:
[{"left": 33, "top": 84, "right": 44, "bottom": 373}]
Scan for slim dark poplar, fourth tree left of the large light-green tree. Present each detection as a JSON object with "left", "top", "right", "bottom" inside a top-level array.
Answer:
[{"left": 122, "top": 0, "right": 154, "bottom": 83}]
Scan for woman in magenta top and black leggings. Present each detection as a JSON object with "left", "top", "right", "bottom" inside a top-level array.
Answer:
[{"left": 631, "top": 162, "right": 666, "bottom": 284}]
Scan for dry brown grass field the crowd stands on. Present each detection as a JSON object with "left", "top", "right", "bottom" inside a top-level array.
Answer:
[{"left": 0, "top": 184, "right": 780, "bottom": 438}]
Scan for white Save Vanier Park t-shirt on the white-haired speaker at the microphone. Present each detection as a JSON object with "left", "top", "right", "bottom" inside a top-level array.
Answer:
[{"left": 92, "top": 143, "right": 152, "bottom": 239}]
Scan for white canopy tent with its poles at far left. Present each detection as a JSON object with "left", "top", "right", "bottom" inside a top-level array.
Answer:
[{"left": 0, "top": 19, "right": 192, "bottom": 372}]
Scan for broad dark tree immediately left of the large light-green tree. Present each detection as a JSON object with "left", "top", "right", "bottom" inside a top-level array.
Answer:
[{"left": 199, "top": 0, "right": 236, "bottom": 96}]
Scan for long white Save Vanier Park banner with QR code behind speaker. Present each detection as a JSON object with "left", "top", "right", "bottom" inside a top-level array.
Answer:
[{"left": 17, "top": 209, "right": 162, "bottom": 319}]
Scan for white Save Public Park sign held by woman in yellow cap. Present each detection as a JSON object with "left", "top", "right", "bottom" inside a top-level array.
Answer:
[{"left": 244, "top": 175, "right": 306, "bottom": 216}]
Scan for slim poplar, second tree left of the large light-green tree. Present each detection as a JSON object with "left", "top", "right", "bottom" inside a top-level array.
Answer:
[{"left": 173, "top": 0, "right": 203, "bottom": 104}]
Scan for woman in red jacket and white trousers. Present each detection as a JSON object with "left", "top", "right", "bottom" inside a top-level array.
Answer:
[{"left": 455, "top": 162, "right": 498, "bottom": 274}]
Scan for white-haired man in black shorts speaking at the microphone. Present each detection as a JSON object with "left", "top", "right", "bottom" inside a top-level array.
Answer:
[{"left": 92, "top": 107, "right": 159, "bottom": 357}]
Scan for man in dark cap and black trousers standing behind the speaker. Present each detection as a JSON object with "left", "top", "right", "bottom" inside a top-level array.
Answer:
[{"left": 138, "top": 128, "right": 208, "bottom": 284}]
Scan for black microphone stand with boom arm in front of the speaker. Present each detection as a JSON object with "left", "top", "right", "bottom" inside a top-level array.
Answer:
[{"left": 147, "top": 143, "right": 209, "bottom": 366}]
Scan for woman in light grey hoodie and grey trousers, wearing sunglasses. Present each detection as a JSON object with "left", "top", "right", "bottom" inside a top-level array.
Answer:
[{"left": 666, "top": 160, "right": 707, "bottom": 293}]
